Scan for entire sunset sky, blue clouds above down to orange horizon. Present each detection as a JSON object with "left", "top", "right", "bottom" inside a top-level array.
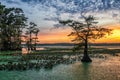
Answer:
[{"left": 0, "top": 0, "right": 120, "bottom": 43}]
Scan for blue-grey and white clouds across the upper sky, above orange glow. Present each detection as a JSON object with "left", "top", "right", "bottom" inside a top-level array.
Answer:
[{"left": 1, "top": 0, "right": 120, "bottom": 29}]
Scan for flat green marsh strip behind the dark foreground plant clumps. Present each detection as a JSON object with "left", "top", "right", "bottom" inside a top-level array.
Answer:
[{"left": 0, "top": 48, "right": 120, "bottom": 63}]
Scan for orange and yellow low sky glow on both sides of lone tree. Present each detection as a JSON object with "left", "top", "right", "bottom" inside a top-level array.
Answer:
[{"left": 39, "top": 24, "right": 120, "bottom": 43}]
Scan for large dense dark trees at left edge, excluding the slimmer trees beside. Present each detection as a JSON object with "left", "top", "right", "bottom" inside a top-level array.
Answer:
[{"left": 0, "top": 3, "right": 27, "bottom": 51}]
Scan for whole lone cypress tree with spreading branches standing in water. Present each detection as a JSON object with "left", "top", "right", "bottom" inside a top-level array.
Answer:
[{"left": 59, "top": 16, "right": 112, "bottom": 62}]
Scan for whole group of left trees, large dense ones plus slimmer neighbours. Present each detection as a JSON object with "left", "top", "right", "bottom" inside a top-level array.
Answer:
[{"left": 0, "top": 3, "right": 39, "bottom": 51}]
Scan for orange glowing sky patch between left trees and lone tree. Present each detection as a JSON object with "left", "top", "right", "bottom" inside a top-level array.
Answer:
[{"left": 39, "top": 29, "right": 71, "bottom": 43}]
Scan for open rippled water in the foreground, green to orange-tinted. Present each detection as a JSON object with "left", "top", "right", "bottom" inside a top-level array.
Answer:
[{"left": 0, "top": 57, "right": 120, "bottom": 80}]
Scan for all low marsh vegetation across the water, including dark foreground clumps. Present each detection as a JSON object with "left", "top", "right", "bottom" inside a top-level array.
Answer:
[{"left": 0, "top": 48, "right": 120, "bottom": 71}]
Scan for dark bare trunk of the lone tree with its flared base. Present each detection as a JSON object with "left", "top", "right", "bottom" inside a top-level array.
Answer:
[{"left": 81, "top": 39, "right": 92, "bottom": 62}]
